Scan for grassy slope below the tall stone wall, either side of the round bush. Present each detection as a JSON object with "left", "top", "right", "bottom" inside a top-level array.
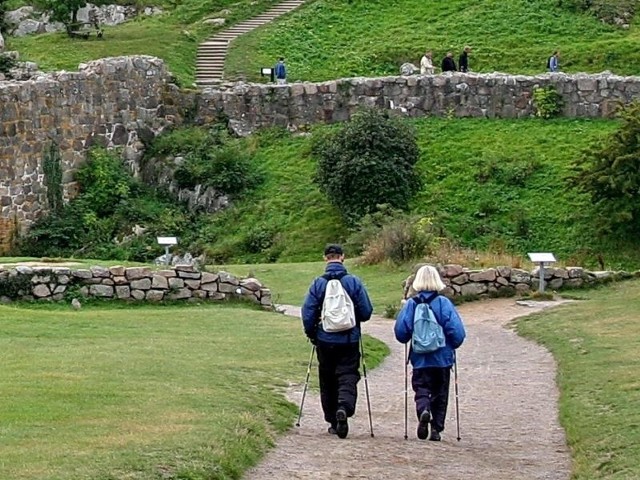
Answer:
[{"left": 205, "top": 118, "right": 640, "bottom": 268}]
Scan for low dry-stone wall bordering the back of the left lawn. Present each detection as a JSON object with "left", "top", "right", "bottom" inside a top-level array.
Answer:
[{"left": 0, "top": 265, "right": 272, "bottom": 308}]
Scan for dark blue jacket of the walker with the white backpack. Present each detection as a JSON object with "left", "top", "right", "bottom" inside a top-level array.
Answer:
[{"left": 302, "top": 262, "right": 373, "bottom": 343}]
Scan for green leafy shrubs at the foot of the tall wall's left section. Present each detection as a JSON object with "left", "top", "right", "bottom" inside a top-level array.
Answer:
[{"left": 18, "top": 149, "right": 192, "bottom": 261}]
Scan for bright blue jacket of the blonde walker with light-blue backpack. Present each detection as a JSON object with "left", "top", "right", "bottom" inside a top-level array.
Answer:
[{"left": 394, "top": 291, "right": 466, "bottom": 368}]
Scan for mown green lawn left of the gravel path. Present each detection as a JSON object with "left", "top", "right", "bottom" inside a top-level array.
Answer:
[{"left": 0, "top": 304, "right": 387, "bottom": 480}]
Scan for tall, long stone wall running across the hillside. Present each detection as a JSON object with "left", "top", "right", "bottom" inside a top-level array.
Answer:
[{"left": 0, "top": 56, "right": 640, "bottom": 249}]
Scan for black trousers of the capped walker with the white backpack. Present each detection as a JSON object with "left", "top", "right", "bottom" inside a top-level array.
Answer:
[{"left": 316, "top": 342, "right": 360, "bottom": 425}]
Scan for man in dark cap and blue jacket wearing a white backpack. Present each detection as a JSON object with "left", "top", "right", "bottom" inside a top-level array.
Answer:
[{"left": 302, "top": 244, "right": 373, "bottom": 438}]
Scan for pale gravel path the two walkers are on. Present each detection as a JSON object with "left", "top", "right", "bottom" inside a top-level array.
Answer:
[{"left": 244, "top": 299, "right": 570, "bottom": 480}]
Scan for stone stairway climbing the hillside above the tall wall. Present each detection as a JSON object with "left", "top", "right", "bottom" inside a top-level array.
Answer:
[{"left": 196, "top": 0, "right": 305, "bottom": 86}]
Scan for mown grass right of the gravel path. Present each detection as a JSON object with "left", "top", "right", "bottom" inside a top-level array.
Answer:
[{"left": 516, "top": 281, "right": 640, "bottom": 480}]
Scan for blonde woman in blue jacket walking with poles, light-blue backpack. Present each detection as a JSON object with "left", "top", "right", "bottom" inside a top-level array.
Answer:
[{"left": 394, "top": 265, "right": 466, "bottom": 442}]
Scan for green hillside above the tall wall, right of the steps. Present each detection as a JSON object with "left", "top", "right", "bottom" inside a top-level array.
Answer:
[{"left": 226, "top": 0, "right": 640, "bottom": 81}]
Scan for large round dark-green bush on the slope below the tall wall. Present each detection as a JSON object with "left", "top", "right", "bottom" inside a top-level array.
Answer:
[{"left": 312, "top": 109, "right": 421, "bottom": 226}]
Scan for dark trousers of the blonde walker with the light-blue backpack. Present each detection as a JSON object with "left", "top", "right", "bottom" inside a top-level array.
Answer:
[{"left": 411, "top": 367, "right": 451, "bottom": 432}]
